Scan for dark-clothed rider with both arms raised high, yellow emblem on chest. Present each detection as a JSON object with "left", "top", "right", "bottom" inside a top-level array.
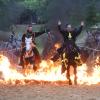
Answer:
[{"left": 57, "top": 21, "right": 84, "bottom": 53}]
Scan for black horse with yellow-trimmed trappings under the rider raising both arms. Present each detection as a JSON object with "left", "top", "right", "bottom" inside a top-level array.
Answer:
[{"left": 52, "top": 40, "right": 82, "bottom": 85}]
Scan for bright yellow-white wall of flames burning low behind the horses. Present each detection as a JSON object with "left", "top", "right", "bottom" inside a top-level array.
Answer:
[{"left": 0, "top": 55, "right": 100, "bottom": 85}]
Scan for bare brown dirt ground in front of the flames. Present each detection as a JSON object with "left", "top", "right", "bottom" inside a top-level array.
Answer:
[{"left": 0, "top": 84, "right": 100, "bottom": 100}]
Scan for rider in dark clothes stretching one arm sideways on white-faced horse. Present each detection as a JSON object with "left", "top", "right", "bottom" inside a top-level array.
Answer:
[{"left": 19, "top": 25, "right": 45, "bottom": 66}]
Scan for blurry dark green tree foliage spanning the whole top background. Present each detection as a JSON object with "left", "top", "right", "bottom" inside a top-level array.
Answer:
[{"left": 0, "top": 0, "right": 100, "bottom": 29}]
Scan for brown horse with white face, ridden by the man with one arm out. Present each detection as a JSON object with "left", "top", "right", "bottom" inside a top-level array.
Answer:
[{"left": 22, "top": 39, "right": 40, "bottom": 72}]
